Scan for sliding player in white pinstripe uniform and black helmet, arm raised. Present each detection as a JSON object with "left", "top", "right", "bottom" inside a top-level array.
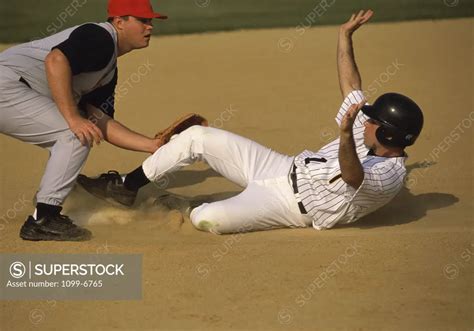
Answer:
[{"left": 78, "top": 10, "right": 423, "bottom": 234}]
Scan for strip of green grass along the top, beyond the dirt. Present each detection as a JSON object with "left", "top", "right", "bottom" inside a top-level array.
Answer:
[{"left": 0, "top": 0, "right": 474, "bottom": 43}]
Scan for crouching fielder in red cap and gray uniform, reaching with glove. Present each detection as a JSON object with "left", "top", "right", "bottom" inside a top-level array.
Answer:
[{"left": 0, "top": 0, "right": 206, "bottom": 241}]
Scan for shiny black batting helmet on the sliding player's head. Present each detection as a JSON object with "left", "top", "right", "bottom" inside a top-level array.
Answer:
[{"left": 362, "top": 93, "right": 423, "bottom": 147}]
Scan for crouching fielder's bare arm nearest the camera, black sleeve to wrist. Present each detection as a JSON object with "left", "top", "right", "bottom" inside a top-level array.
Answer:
[{"left": 45, "top": 49, "right": 80, "bottom": 124}]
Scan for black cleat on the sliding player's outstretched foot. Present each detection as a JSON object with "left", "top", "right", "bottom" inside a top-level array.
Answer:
[{"left": 77, "top": 170, "right": 138, "bottom": 207}]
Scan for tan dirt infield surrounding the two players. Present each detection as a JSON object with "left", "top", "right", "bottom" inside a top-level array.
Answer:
[{"left": 0, "top": 19, "right": 474, "bottom": 330}]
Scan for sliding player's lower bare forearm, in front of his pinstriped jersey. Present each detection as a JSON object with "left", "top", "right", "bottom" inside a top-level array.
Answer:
[{"left": 339, "top": 132, "right": 364, "bottom": 189}]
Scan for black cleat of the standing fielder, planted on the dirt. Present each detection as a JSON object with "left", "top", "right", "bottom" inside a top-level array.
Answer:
[{"left": 20, "top": 214, "right": 92, "bottom": 241}]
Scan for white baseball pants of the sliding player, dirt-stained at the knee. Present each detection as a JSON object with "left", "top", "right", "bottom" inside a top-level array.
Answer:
[{"left": 143, "top": 126, "right": 312, "bottom": 234}]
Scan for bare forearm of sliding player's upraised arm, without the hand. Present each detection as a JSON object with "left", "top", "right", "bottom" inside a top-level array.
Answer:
[{"left": 337, "top": 29, "right": 362, "bottom": 98}]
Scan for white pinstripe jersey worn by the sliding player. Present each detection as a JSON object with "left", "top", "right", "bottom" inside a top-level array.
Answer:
[{"left": 295, "top": 90, "right": 406, "bottom": 230}]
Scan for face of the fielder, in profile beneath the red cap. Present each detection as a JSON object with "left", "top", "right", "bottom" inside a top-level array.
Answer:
[{"left": 123, "top": 16, "right": 153, "bottom": 49}]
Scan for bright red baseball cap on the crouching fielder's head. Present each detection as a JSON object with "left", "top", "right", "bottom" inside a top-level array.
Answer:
[{"left": 107, "top": 0, "right": 168, "bottom": 19}]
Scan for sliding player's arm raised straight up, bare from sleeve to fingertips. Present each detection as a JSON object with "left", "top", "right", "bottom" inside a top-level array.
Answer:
[{"left": 337, "top": 9, "right": 374, "bottom": 99}]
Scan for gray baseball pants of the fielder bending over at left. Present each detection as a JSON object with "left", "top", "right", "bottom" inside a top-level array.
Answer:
[{"left": 0, "top": 65, "right": 90, "bottom": 206}]
